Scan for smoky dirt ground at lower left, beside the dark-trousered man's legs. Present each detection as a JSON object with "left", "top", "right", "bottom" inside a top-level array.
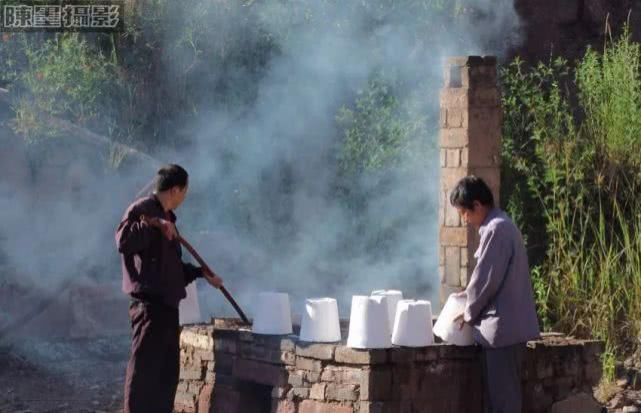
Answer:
[{"left": 0, "top": 336, "right": 129, "bottom": 413}]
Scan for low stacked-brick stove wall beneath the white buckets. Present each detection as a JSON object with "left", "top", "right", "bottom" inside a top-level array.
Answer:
[{"left": 175, "top": 326, "right": 602, "bottom": 413}]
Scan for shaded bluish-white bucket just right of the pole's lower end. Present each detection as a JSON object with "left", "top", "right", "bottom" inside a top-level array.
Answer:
[{"left": 252, "top": 292, "right": 292, "bottom": 334}]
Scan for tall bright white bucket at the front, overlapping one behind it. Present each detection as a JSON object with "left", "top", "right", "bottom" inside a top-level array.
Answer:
[{"left": 347, "top": 295, "right": 392, "bottom": 348}]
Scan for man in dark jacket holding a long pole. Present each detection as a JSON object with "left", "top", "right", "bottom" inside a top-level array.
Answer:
[{"left": 116, "top": 165, "right": 222, "bottom": 413}]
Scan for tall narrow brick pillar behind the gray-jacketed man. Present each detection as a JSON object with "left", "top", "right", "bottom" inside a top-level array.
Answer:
[{"left": 439, "top": 56, "right": 502, "bottom": 302}]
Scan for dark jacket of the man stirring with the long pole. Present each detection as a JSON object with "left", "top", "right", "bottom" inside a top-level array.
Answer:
[{"left": 116, "top": 195, "right": 202, "bottom": 308}]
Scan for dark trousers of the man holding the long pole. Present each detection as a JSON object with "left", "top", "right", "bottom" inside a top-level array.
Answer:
[{"left": 124, "top": 301, "right": 180, "bottom": 413}]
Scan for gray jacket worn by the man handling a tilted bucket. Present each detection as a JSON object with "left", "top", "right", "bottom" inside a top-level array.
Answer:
[{"left": 464, "top": 208, "right": 539, "bottom": 348}]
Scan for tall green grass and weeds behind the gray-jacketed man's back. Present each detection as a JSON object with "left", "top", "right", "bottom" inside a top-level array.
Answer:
[{"left": 501, "top": 30, "right": 641, "bottom": 376}]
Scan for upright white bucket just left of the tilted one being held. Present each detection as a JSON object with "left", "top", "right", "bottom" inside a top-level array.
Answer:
[{"left": 392, "top": 300, "right": 434, "bottom": 347}]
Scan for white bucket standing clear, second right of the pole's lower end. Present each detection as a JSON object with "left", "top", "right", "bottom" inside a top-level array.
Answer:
[{"left": 299, "top": 298, "right": 341, "bottom": 343}]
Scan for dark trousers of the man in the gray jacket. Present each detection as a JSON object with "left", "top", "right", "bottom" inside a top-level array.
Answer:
[{"left": 481, "top": 343, "right": 525, "bottom": 413}]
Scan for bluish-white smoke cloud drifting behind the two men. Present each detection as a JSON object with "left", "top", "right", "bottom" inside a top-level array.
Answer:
[{"left": 0, "top": 0, "right": 519, "bottom": 326}]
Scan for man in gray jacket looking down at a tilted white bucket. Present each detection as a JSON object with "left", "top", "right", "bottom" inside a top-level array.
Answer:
[{"left": 450, "top": 176, "right": 539, "bottom": 413}]
